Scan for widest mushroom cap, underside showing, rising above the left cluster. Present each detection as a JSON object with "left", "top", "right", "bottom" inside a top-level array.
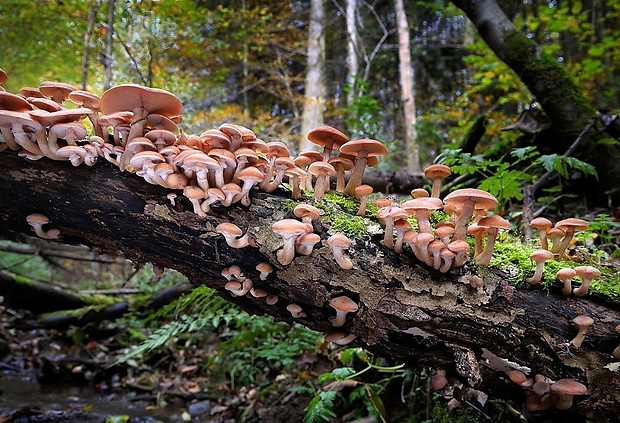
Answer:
[{"left": 101, "top": 84, "right": 183, "bottom": 117}]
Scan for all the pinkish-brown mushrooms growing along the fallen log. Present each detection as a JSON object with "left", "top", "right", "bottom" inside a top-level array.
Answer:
[{"left": 0, "top": 69, "right": 620, "bottom": 410}]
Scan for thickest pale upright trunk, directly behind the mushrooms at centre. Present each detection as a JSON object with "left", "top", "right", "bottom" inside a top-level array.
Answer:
[{"left": 300, "top": 0, "right": 325, "bottom": 150}]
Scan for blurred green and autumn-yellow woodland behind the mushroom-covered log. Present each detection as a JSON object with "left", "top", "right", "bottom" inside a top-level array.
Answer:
[{"left": 0, "top": 0, "right": 620, "bottom": 419}]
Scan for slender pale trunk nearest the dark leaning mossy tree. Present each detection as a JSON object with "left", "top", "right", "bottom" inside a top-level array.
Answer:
[{"left": 394, "top": 0, "right": 422, "bottom": 175}]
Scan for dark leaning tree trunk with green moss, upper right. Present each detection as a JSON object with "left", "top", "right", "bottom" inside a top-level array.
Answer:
[{"left": 453, "top": 0, "right": 620, "bottom": 204}]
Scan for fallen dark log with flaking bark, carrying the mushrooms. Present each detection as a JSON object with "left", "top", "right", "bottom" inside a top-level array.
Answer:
[{"left": 0, "top": 150, "right": 620, "bottom": 421}]
